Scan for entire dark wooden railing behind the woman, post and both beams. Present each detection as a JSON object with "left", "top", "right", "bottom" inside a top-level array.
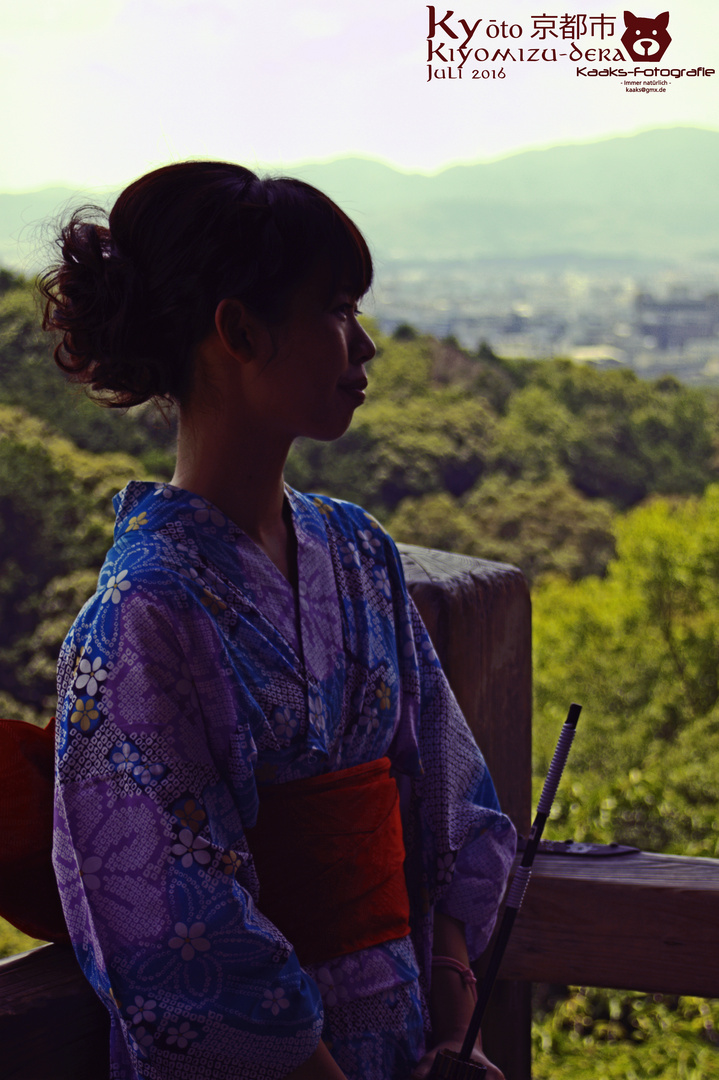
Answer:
[{"left": 0, "top": 545, "right": 719, "bottom": 1080}]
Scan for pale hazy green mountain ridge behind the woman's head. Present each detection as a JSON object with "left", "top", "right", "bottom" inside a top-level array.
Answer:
[{"left": 0, "top": 127, "right": 719, "bottom": 269}]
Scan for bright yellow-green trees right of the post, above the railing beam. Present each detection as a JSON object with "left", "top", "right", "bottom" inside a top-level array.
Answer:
[{"left": 534, "top": 485, "right": 719, "bottom": 856}]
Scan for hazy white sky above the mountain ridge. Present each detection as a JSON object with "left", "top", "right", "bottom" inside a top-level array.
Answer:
[{"left": 0, "top": 0, "right": 719, "bottom": 191}]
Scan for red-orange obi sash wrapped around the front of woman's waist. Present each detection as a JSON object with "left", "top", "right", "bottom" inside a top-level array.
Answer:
[{"left": 247, "top": 757, "right": 409, "bottom": 963}]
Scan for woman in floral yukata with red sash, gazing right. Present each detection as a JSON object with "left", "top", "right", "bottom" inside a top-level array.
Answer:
[{"left": 43, "top": 162, "right": 514, "bottom": 1080}]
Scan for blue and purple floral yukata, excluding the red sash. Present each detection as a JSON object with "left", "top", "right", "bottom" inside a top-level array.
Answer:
[{"left": 53, "top": 482, "right": 515, "bottom": 1080}]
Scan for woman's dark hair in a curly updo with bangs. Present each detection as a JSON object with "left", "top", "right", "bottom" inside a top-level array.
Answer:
[{"left": 40, "top": 161, "right": 372, "bottom": 408}]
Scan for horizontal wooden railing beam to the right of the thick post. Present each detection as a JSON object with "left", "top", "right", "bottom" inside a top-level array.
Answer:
[{"left": 501, "top": 852, "right": 719, "bottom": 998}]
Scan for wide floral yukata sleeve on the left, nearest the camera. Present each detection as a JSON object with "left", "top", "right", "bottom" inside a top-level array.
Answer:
[{"left": 53, "top": 568, "right": 323, "bottom": 1080}]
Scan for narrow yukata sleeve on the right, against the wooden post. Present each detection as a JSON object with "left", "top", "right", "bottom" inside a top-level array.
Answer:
[{"left": 392, "top": 535, "right": 516, "bottom": 963}]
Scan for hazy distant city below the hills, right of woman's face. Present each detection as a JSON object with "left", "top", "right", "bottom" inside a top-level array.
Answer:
[{"left": 370, "top": 259, "right": 719, "bottom": 382}]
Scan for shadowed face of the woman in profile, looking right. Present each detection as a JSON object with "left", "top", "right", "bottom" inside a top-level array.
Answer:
[{"left": 241, "top": 272, "right": 376, "bottom": 441}]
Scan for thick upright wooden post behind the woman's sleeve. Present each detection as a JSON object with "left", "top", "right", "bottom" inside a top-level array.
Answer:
[{"left": 398, "top": 544, "right": 531, "bottom": 1080}]
